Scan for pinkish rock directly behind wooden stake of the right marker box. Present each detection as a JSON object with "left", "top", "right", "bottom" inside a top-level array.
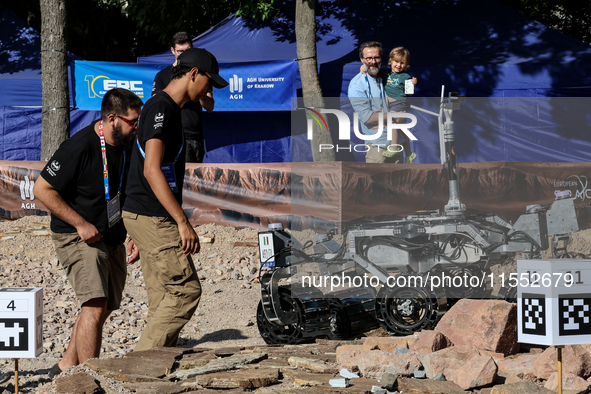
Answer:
[{"left": 534, "top": 345, "right": 591, "bottom": 380}]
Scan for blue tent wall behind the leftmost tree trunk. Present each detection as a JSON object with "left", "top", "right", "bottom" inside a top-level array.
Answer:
[{"left": 0, "top": 9, "right": 100, "bottom": 160}]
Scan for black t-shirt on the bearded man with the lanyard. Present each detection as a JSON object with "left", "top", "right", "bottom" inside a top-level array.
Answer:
[{"left": 41, "top": 120, "right": 130, "bottom": 246}]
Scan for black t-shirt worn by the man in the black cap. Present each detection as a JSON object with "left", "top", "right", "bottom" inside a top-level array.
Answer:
[{"left": 123, "top": 91, "right": 186, "bottom": 217}]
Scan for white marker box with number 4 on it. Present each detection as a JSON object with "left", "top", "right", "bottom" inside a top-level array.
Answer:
[{"left": 0, "top": 287, "right": 43, "bottom": 358}]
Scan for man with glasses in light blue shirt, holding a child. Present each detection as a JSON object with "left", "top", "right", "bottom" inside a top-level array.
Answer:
[{"left": 348, "top": 41, "right": 404, "bottom": 163}]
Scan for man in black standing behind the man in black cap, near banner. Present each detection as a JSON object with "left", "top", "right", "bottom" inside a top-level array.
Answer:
[{"left": 152, "top": 31, "right": 215, "bottom": 163}]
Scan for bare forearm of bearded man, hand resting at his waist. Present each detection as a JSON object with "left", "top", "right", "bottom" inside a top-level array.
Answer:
[{"left": 33, "top": 176, "right": 103, "bottom": 244}]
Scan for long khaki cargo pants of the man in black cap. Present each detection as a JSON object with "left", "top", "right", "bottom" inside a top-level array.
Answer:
[{"left": 123, "top": 211, "right": 201, "bottom": 351}]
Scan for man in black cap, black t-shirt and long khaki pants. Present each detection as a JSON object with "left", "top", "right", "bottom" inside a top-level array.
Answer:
[{"left": 123, "top": 48, "right": 228, "bottom": 350}]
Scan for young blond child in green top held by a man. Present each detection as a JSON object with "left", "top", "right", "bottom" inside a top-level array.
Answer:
[{"left": 361, "top": 47, "right": 417, "bottom": 164}]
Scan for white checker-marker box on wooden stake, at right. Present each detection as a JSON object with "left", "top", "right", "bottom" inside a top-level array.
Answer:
[{"left": 516, "top": 259, "right": 591, "bottom": 393}]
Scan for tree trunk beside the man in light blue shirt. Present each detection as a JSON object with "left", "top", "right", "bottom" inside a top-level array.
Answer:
[{"left": 295, "top": 0, "right": 335, "bottom": 162}]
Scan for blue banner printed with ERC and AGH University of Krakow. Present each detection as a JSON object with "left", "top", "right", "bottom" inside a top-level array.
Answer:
[{"left": 73, "top": 60, "right": 297, "bottom": 111}]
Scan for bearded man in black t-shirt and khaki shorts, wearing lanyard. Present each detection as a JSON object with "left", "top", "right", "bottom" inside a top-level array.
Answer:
[{"left": 33, "top": 88, "right": 143, "bottom": 378}]
